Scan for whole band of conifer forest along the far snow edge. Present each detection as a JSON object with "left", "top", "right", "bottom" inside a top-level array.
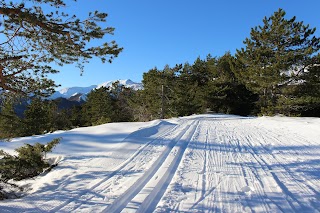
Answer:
[{"left": 0, "top": 9, "right": 320, "bottom": 138}]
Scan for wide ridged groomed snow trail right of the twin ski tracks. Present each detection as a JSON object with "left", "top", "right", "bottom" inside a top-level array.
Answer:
[{"left": 156, "top": 117, "right": 320, "bottom": 213}]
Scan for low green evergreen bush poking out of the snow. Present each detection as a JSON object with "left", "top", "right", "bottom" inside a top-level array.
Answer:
[{"left": 0, "top": 138, "right": 61, "bottom": 182}]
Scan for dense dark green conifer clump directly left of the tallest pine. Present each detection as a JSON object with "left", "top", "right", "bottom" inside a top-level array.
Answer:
[{"left": 134, "top": 53, "right": 257, "bottom": 120}]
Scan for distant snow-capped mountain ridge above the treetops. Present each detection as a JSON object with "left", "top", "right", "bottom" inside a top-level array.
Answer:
[{"left": 50, "top": 79, "right": 143, "bottom": 101}]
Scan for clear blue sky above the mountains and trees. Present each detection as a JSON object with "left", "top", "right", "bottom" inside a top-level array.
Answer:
[{"left": 50, "top": 0, "right": 320, "bottom": 87}]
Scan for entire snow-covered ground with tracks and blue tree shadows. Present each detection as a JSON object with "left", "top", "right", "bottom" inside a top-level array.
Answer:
[{"left": 0, "top": 115, "right": 320, "bottom": 213}]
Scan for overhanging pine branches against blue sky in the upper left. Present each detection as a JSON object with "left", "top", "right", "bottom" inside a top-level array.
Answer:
[{"left": 0, "top": 0, "right": 122, "bottom": 96}]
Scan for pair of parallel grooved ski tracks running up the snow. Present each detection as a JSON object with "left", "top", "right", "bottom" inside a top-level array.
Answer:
[{"left": 103, "top": 120, "right": 197, "bottom": 212}]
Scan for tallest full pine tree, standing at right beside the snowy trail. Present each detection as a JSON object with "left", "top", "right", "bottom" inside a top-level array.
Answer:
[{"left": 236, "top": 9, "right": 320, "bottom": 113}]
